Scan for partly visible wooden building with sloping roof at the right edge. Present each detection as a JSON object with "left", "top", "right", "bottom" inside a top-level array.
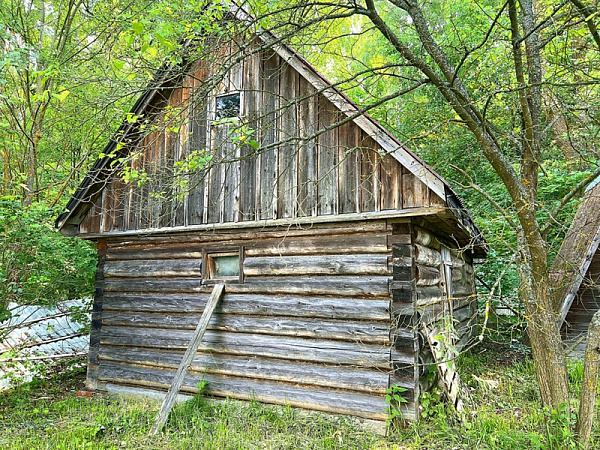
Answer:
[{"left": 552, "top": 181, "right": 600, "bottom": 356}]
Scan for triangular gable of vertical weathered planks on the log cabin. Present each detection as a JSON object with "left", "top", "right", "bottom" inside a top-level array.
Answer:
[{"left": 80, "top": 42, "right": 443, "bottom": 235}]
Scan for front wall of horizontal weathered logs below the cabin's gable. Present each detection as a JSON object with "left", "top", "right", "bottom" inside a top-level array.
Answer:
[{"left": 98, "top": 221, "right": 418, "bottom": 420}]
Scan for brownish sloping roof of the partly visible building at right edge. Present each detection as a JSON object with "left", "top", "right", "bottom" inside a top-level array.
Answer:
[{"left": 550, "top": 182, "right": 600, "bottom": 327}]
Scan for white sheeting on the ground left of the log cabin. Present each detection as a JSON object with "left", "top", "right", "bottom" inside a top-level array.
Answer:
[{"left": 0, "top": 300, "right": 89, "bottom": 390}]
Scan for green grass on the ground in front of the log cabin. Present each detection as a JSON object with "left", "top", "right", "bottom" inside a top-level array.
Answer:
[{"left": 0, "top": 345, "right": 600, "bottom": 450}]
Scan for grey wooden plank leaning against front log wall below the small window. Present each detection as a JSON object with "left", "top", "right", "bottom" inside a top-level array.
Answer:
[{"left": 150, "top": 284, "right": 225, "bottom": 435}]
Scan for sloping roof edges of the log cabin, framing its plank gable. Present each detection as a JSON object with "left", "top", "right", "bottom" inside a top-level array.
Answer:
[{"left": 55, "top": 26, "right": 487, "bottom": 256}]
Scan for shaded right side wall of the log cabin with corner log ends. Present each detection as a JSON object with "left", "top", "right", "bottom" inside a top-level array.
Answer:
[{"left": 390, "top": 223, "right": 477, "bottom": 410}]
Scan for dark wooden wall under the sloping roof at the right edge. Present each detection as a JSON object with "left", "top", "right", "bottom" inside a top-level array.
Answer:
[{"left": 561, "top": 251, "right": 600, "bottom": 354}]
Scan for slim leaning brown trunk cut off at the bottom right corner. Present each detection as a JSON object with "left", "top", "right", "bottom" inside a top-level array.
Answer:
[{"left": 575, "top": 311, "right": 600, "bottom": 448}]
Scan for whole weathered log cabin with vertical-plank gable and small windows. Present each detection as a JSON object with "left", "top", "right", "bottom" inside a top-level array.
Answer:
[{"left": 57, "top": 29, "right": 485, "bottom": 421}]
